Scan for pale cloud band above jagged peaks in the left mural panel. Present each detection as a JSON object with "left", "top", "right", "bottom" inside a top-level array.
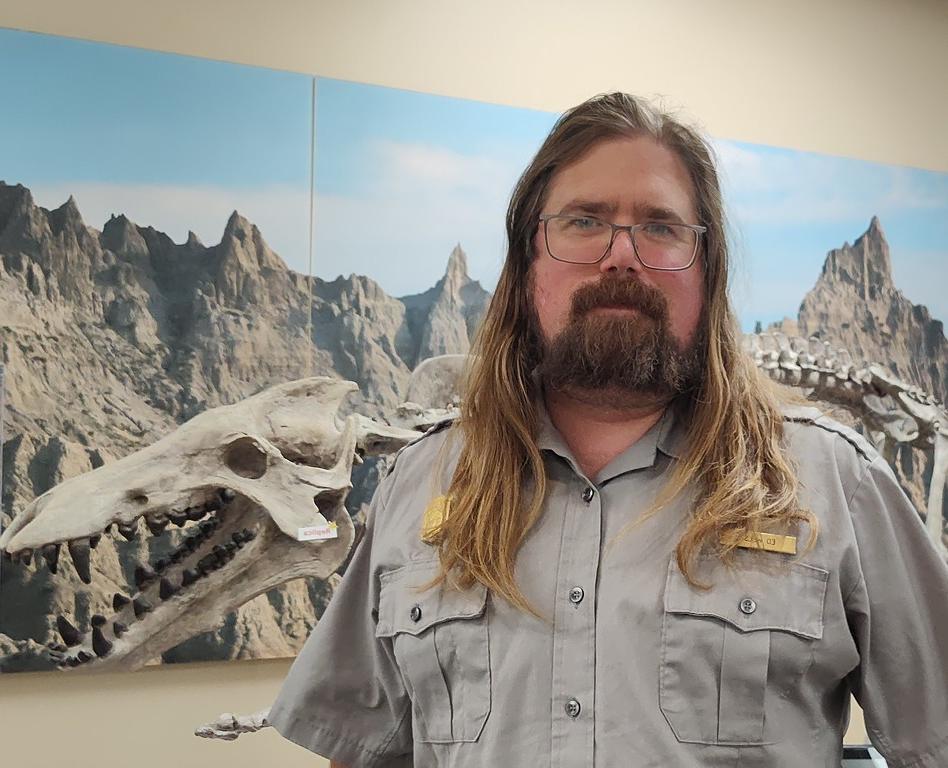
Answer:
[{"left": 30, "top": 182, "right": 309, "bottom": 273}]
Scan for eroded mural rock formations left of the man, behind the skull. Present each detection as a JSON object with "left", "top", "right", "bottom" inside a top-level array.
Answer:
[{"left": 0, "top": 182, "right": 486, "bottom": 668}]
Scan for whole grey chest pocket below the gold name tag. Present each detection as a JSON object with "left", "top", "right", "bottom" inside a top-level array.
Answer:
[{"left": 659, "top": 558, "right": 829, "bottom": 745}]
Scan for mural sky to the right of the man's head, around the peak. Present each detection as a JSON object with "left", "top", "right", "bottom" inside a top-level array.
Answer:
[{"left": 715, "top": 140, "right": 948, "bottom": 329}]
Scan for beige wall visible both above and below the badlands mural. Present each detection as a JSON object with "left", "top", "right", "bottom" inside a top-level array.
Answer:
[{"left": 0, "top": 0, "right": 948, "bottom": 768}]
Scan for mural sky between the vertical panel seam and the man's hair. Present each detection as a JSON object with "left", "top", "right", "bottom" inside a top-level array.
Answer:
[{"left": 313, "top": 78, "right": 555, "bottom": 296}]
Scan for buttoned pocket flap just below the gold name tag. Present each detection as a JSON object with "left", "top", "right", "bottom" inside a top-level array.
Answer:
[{"left": 665, "top": 557, "right": 829, "bottom": 640}]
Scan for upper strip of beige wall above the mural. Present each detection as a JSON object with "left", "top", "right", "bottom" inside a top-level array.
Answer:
[{"left": 0, "top": 0, "right": 948, "bottom": 171}]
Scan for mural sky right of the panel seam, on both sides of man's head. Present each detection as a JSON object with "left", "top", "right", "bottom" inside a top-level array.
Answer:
[{"left": 314, "top": 79, "right": 948, "bottom": 330}]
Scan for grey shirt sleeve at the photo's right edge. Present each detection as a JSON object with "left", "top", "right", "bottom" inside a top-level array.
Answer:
[{"left": 847, "top": 458, "right": 948, "bottom": 768}]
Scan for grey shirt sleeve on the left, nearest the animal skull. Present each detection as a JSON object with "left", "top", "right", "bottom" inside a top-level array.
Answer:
[{"left": 268, "top": 475, "right": 412, "bottom": 768}]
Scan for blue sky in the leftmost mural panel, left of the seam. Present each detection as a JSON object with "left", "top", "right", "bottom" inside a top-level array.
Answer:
[{"left": 0, "top": 29, "right": 312, "bottom": 271}]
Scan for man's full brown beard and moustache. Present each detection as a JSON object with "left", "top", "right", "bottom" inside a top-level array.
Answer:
[{"left": 531, "top": 277, "right": 705, "bottom": 409}]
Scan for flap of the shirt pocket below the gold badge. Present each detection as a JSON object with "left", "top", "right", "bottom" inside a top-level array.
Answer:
[{"left": 375, "top": 560, "right": 487, "bottom": 637}]
